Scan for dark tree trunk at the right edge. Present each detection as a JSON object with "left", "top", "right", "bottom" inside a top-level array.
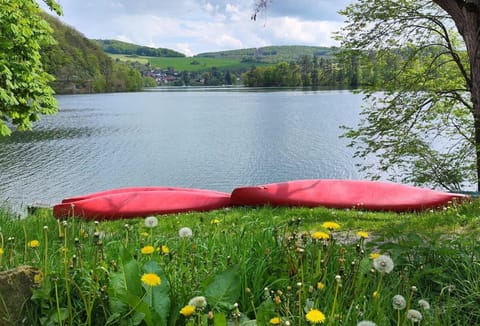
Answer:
[{"left": 433, "top": 0, "right": 480, "bottom": 191}]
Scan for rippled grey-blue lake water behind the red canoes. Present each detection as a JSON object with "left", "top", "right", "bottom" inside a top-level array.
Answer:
[{"left": 0, "top": 88, "right": 362, "bottom": 214}]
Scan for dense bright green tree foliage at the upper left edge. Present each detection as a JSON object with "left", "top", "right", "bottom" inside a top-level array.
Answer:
[{"left": 0, "top": 0, "right": 61, "bottom": 136}]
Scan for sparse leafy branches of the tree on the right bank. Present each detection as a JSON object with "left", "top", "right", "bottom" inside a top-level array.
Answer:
[{"left": 339, "top": 0, "right": 477, "bottom": 190}]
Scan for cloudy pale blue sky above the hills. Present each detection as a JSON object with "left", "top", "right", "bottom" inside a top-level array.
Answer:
[{"left": 38, "top": 0, "right": 352, "bottom": 56}]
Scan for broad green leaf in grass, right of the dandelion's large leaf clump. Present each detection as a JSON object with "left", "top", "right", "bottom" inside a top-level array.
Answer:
[{"left": 204, "top": 265, "right": 241, "bottom": 307}]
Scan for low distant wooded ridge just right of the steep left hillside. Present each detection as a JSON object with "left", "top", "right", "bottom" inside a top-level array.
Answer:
[{"left": 93, "top": 40, "right": 185, "bottom": 57}]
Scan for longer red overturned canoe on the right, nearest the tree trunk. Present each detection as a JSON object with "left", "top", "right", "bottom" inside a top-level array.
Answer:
[{"left": 230, "top": 179, "right": 469, "bottom": 212}]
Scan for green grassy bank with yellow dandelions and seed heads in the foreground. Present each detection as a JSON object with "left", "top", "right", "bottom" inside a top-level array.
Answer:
[{"left": 0, "top": 200, "right": 480, "bottom": 326}]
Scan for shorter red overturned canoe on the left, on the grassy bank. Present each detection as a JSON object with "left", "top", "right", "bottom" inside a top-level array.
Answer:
[{"left": 53, "top": 188, "right": 230, "bottom": 220}]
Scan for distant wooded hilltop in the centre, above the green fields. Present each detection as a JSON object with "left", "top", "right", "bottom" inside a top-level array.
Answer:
[{"left": 195, "top": 45, "right": 337, "bottom": 63}]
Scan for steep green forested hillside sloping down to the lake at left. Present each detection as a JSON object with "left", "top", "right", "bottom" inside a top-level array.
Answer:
[{"left": 42, "top": 13, "right": 143, "bottom": 94}]
